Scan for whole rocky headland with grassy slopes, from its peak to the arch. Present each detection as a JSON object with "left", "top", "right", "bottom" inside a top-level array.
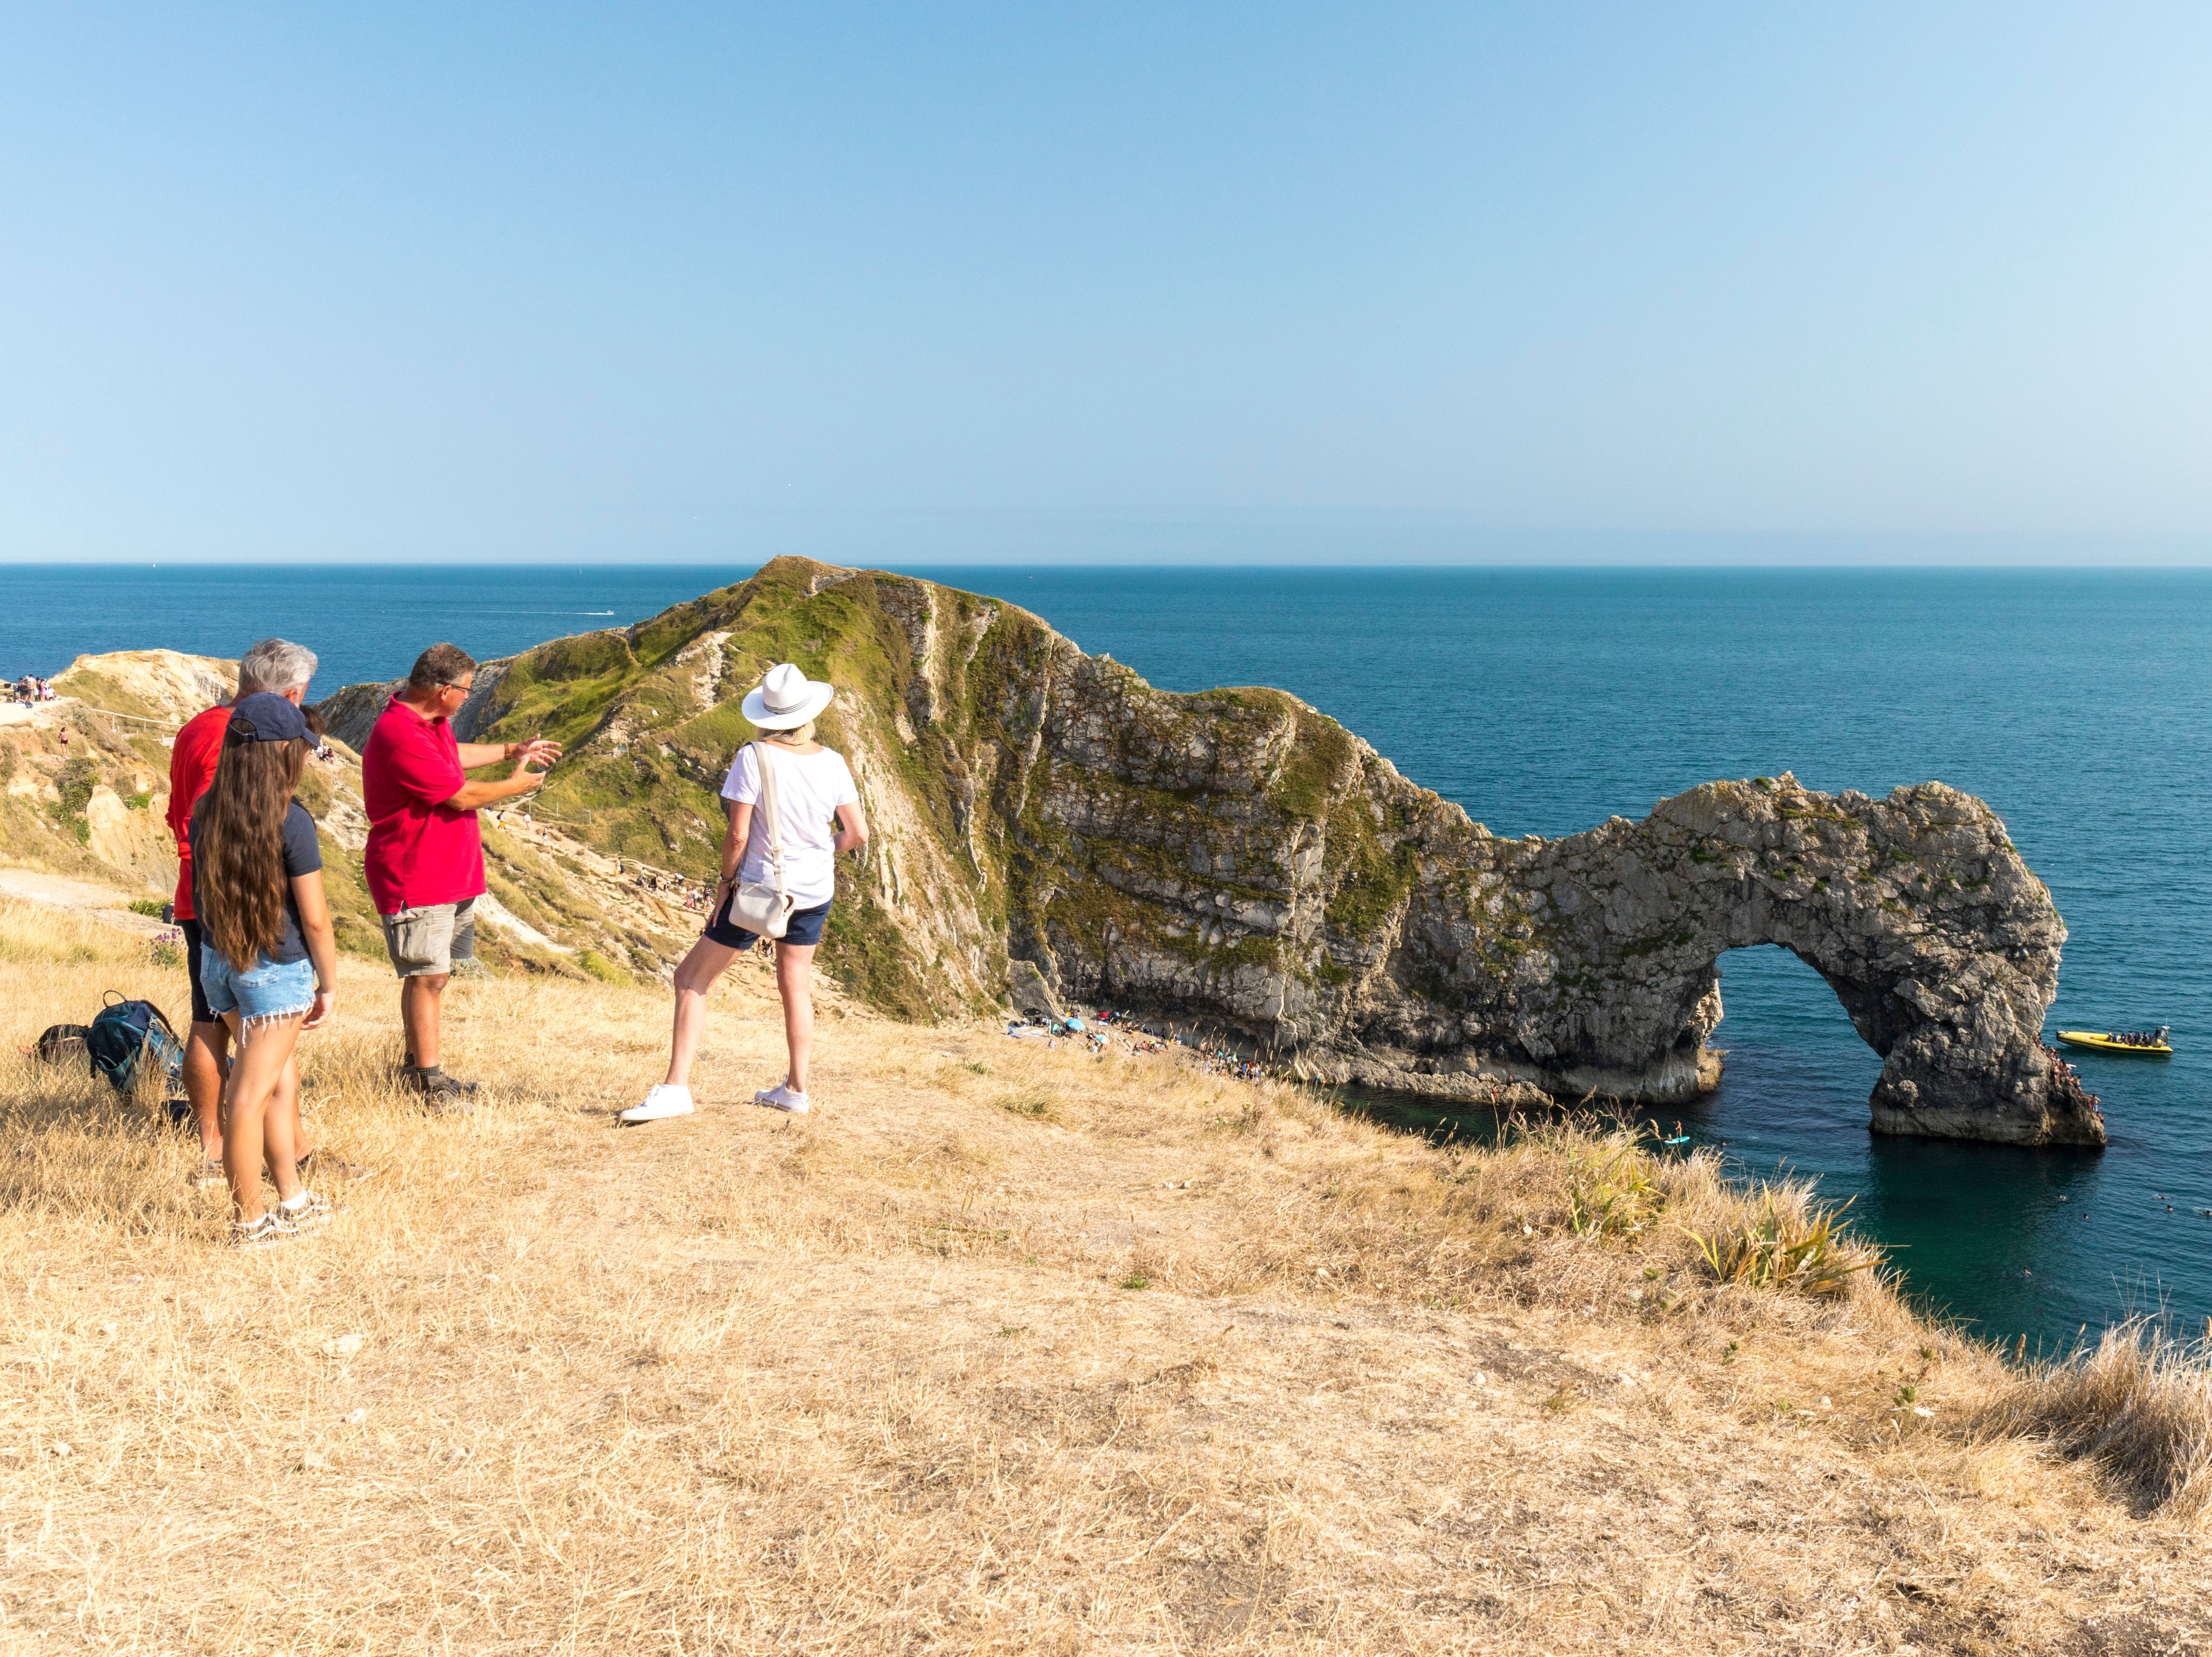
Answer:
[{"left": 307, "top": 560, "right": 2104, "bottom": 1144}]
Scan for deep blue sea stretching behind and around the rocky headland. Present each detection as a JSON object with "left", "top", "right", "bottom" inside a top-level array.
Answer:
[{"left": 0, "top": 566, "right": 2212, "bottom": 1352}]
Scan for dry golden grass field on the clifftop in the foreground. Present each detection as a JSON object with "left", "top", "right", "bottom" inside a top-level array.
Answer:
[{"left": 0, "top": 905, "right": 2212, "bottom": 1655}]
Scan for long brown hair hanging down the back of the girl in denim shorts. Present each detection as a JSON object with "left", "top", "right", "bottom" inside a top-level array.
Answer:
[{"left": 192, "top": 737, "right": 307, "bottom": 973}]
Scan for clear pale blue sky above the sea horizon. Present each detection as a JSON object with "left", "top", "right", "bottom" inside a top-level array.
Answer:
[{"left": 0, "top": 0, "right": 2212, "bottom": 564}]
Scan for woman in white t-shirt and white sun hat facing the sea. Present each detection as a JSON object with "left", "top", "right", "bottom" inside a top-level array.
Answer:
[{"left": 621, "top": 662, "right": 867, "bottom": 1121}]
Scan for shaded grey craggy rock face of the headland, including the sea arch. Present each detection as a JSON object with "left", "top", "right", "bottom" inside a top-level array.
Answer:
[{"left": 991, "top": 641, "right": 2104, "bottom": 1144}]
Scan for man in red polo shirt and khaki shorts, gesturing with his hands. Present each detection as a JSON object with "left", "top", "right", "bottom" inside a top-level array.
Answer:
[{"left": 361, "top": 644, "right": 560, "bottom": 1113}]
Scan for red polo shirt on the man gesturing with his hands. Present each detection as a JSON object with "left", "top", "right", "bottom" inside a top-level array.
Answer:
[{"left": 361, "top": 697, "right": 485, "bottom": 916}]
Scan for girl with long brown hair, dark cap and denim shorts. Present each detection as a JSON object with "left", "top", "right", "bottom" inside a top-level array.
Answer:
[{"left": 192, "top": 690, "right": 338, "bottom": 1248}]
